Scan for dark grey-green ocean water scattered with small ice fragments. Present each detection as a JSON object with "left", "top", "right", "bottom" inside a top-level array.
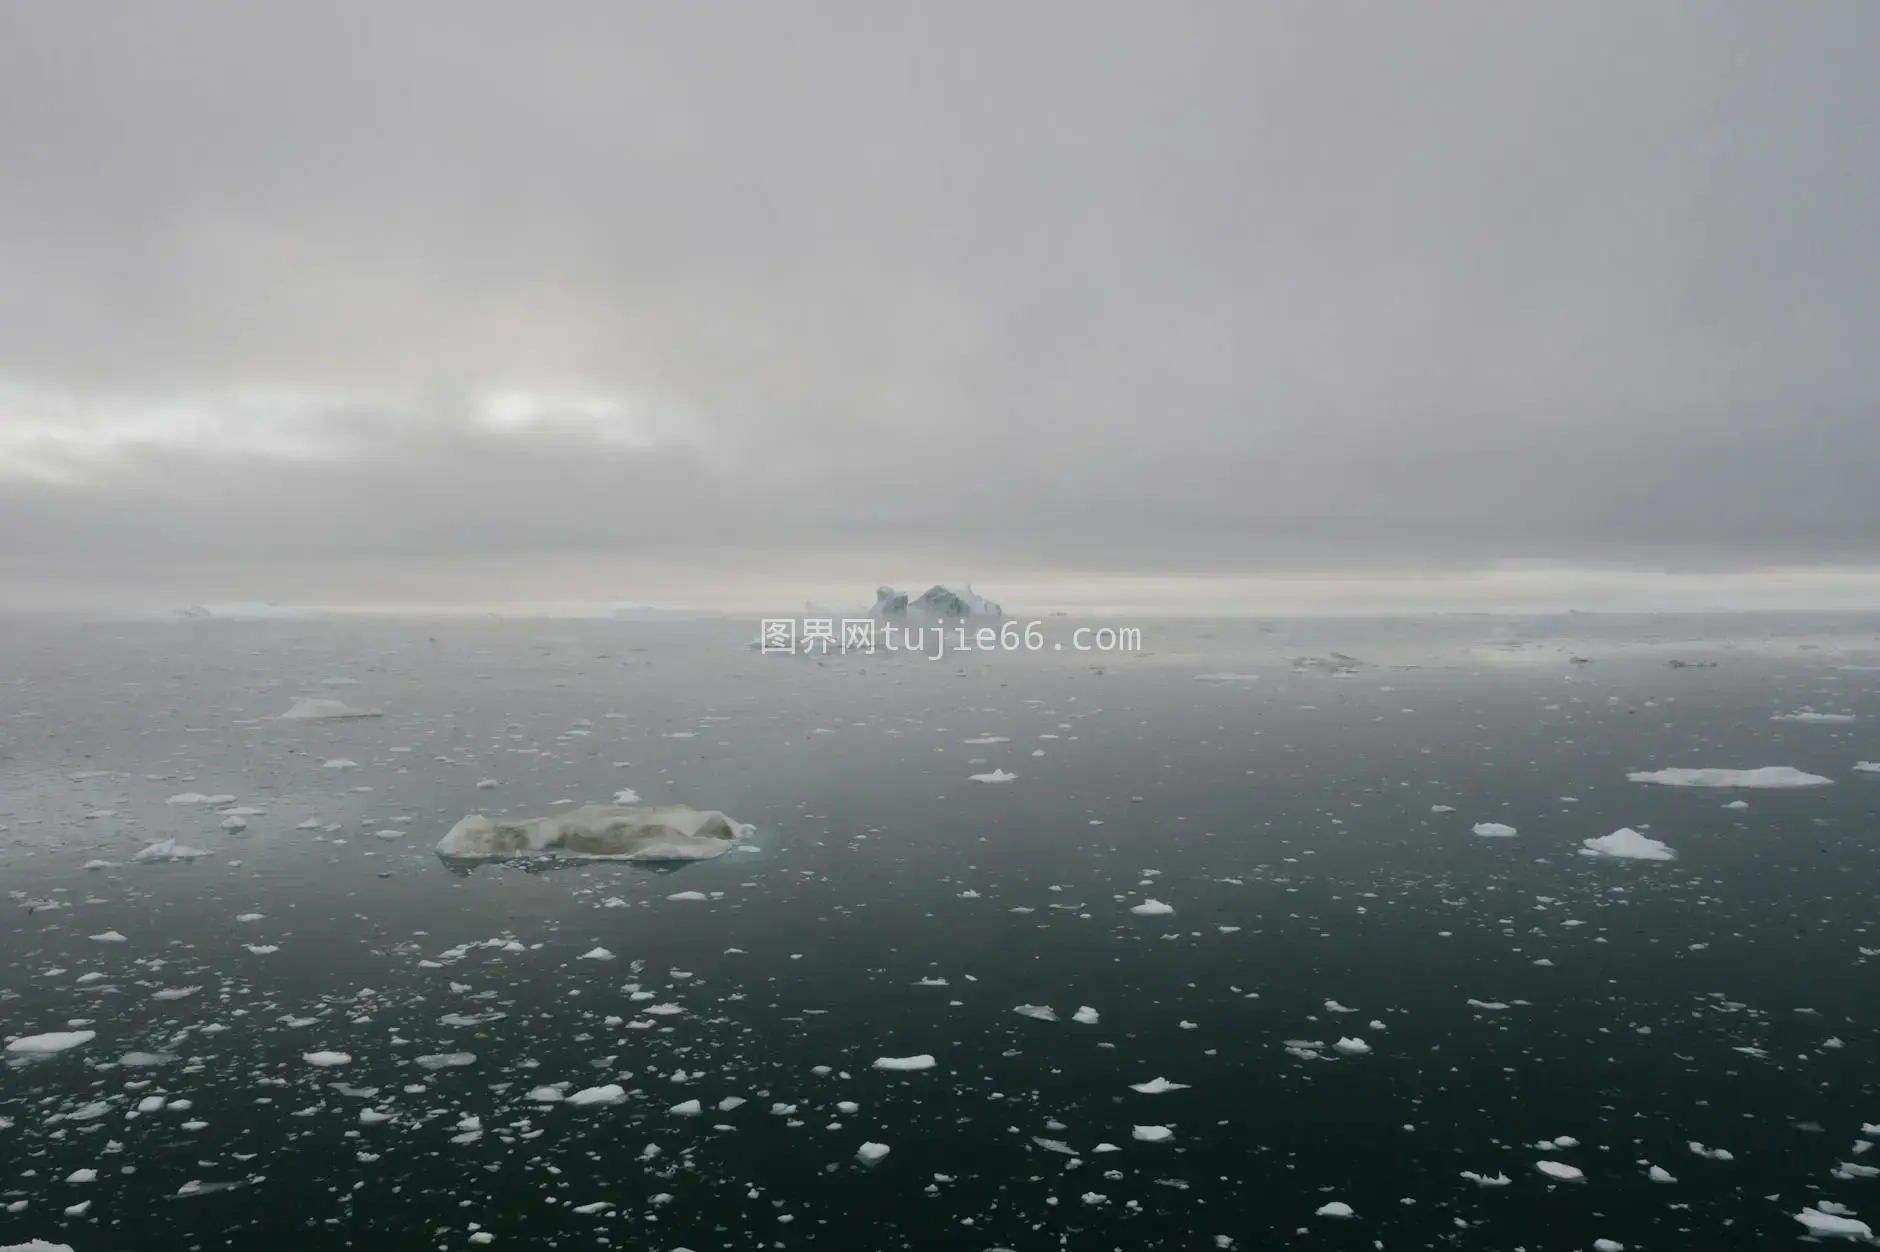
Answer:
[{"left": 0, "top": 617, "right": 1880, "bottom": 1252}]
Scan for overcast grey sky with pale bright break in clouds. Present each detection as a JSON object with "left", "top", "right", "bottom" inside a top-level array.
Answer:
[{"left": 0, "top": 0, "right": 1880, "bottom": 603}]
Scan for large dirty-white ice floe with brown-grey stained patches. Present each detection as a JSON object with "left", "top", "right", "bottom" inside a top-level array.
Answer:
[{"left": 438, "top": 805, "right": 756, "bottom": 861}]
